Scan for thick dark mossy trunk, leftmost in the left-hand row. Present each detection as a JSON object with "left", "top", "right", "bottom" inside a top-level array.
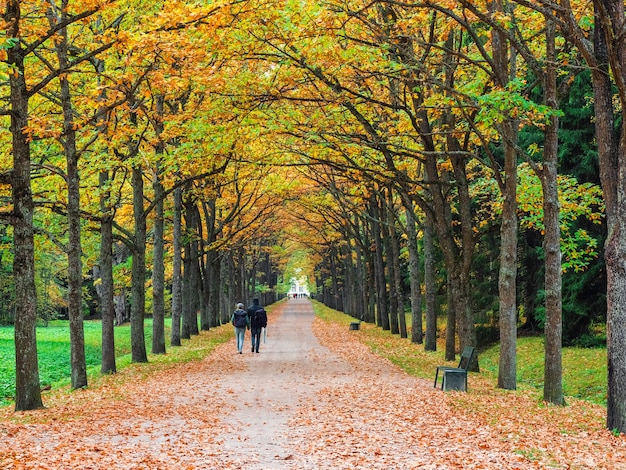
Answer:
[{"left": 4, "top": 0, "right": 43, "bottom": 411}]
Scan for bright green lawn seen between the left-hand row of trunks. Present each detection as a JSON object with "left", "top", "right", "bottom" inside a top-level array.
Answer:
[{"left": 0, "top": 319, "right": 232, "bottom": 406}]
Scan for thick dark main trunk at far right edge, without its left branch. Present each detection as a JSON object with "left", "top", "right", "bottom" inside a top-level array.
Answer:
[{"left": 593, "top": 0, "right": 626, "bottom": 433}]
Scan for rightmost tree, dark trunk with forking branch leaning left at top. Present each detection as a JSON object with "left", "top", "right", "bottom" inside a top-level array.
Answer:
[{"left": 550, "top": 0, "right": 626, "bottom": 432}]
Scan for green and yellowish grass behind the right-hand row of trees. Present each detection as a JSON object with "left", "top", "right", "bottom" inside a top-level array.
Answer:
[{"left": 314, "top": 302, "right": 607, "bottom": 405}]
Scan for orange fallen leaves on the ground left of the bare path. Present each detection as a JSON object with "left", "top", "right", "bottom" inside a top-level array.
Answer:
[{"left": 0, "top": 330, "right": 246, "bottom": 470}]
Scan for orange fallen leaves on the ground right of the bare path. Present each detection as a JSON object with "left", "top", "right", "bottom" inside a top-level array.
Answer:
[{"left": 296, "top": 319, "right": 626, "bottom": 469}]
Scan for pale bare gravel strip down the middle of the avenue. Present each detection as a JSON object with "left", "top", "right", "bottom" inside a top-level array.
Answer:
[{"left": 214, "top": 299, "right": 349, "bottom": 469}]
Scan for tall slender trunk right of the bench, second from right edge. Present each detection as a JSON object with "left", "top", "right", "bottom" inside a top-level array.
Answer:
[{"left": 539, "top": 18, "right": 565, "bottom": 405}]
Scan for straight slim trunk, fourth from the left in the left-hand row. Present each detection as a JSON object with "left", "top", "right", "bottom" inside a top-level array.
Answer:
[{"left": 130, "top": 167, "right": 148, "bottom": 362}]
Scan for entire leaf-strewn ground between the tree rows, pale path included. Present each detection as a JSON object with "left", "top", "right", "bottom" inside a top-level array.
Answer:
[{"left": 0, "top": 299, "right": 626, "bottom": 470}]
